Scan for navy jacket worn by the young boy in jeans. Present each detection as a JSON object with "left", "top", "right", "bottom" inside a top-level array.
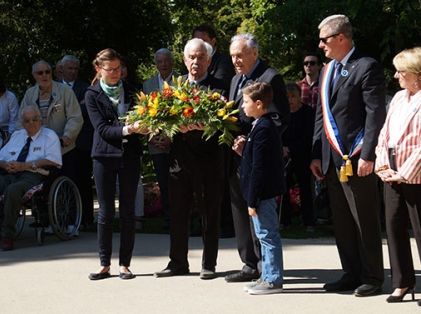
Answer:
[{"left": 240, "top": 114, "right": 284, "bottom": 208}]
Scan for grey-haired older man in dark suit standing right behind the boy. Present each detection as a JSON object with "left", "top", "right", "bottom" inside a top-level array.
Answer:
[{"left": 225, "top": 34, "right": 289, "bottom": 282}]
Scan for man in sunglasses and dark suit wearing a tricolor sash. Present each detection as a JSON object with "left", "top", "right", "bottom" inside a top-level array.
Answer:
[{"left": 310, "top": 15, "right": 386, "bottom": 297}]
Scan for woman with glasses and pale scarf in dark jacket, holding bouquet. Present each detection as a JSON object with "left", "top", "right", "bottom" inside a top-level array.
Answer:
[{"left": 85, "top": 48, "right": 142, "bottom": 280}]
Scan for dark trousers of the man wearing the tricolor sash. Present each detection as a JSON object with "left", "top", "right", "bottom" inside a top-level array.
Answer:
[{"left": 326, "top": 163, "right": 384, "bottom": 285}]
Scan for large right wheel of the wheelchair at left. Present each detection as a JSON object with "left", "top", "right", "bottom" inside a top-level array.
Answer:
[{"left": 48, "top": 176, "right": 82, "bottom": 240}]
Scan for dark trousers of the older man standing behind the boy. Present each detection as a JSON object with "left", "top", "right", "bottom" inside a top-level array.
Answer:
[{"left": 230, "top": 167, "right": 261, "bottom": 272}]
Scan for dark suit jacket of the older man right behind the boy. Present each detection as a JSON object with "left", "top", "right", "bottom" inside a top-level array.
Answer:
[{"left": 229, "top": 60, "right": 289, "bottom": 134}]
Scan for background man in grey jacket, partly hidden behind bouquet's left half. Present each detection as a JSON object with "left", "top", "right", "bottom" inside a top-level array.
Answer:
[{"left": 143, "top": 48, "right": 175, "bottom": 228}]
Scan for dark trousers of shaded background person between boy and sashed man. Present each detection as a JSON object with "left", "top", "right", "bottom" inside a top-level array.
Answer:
[{"left": 281, "top": 156, "right": 316, "bottom": 226}]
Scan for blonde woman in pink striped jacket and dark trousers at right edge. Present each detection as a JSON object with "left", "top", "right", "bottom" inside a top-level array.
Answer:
[{"left": 376, "top": 47, "right": 421, "bottom": 305}]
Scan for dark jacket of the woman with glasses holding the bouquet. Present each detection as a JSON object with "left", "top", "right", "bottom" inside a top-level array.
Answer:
[{"left": 85, "top": 83, "right": 142, "bottom": 158}]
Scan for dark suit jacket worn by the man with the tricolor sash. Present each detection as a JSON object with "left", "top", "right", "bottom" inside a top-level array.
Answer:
[{"left": 313, "top": 50, "right": 386, "bottom": 173}]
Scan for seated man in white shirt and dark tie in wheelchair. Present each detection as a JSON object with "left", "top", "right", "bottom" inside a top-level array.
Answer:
[{"left": 0, "top": 105, "right": 62, "bottom": 251}]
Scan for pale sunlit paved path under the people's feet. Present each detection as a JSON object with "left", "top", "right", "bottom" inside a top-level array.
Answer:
[{"left": 0, "top": 229, "right": 421, "bottom": 314}]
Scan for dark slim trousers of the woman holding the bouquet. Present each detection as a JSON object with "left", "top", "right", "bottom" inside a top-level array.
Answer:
[{"left": 93, "top": 156, "right": 140, "bottom": 267}]
